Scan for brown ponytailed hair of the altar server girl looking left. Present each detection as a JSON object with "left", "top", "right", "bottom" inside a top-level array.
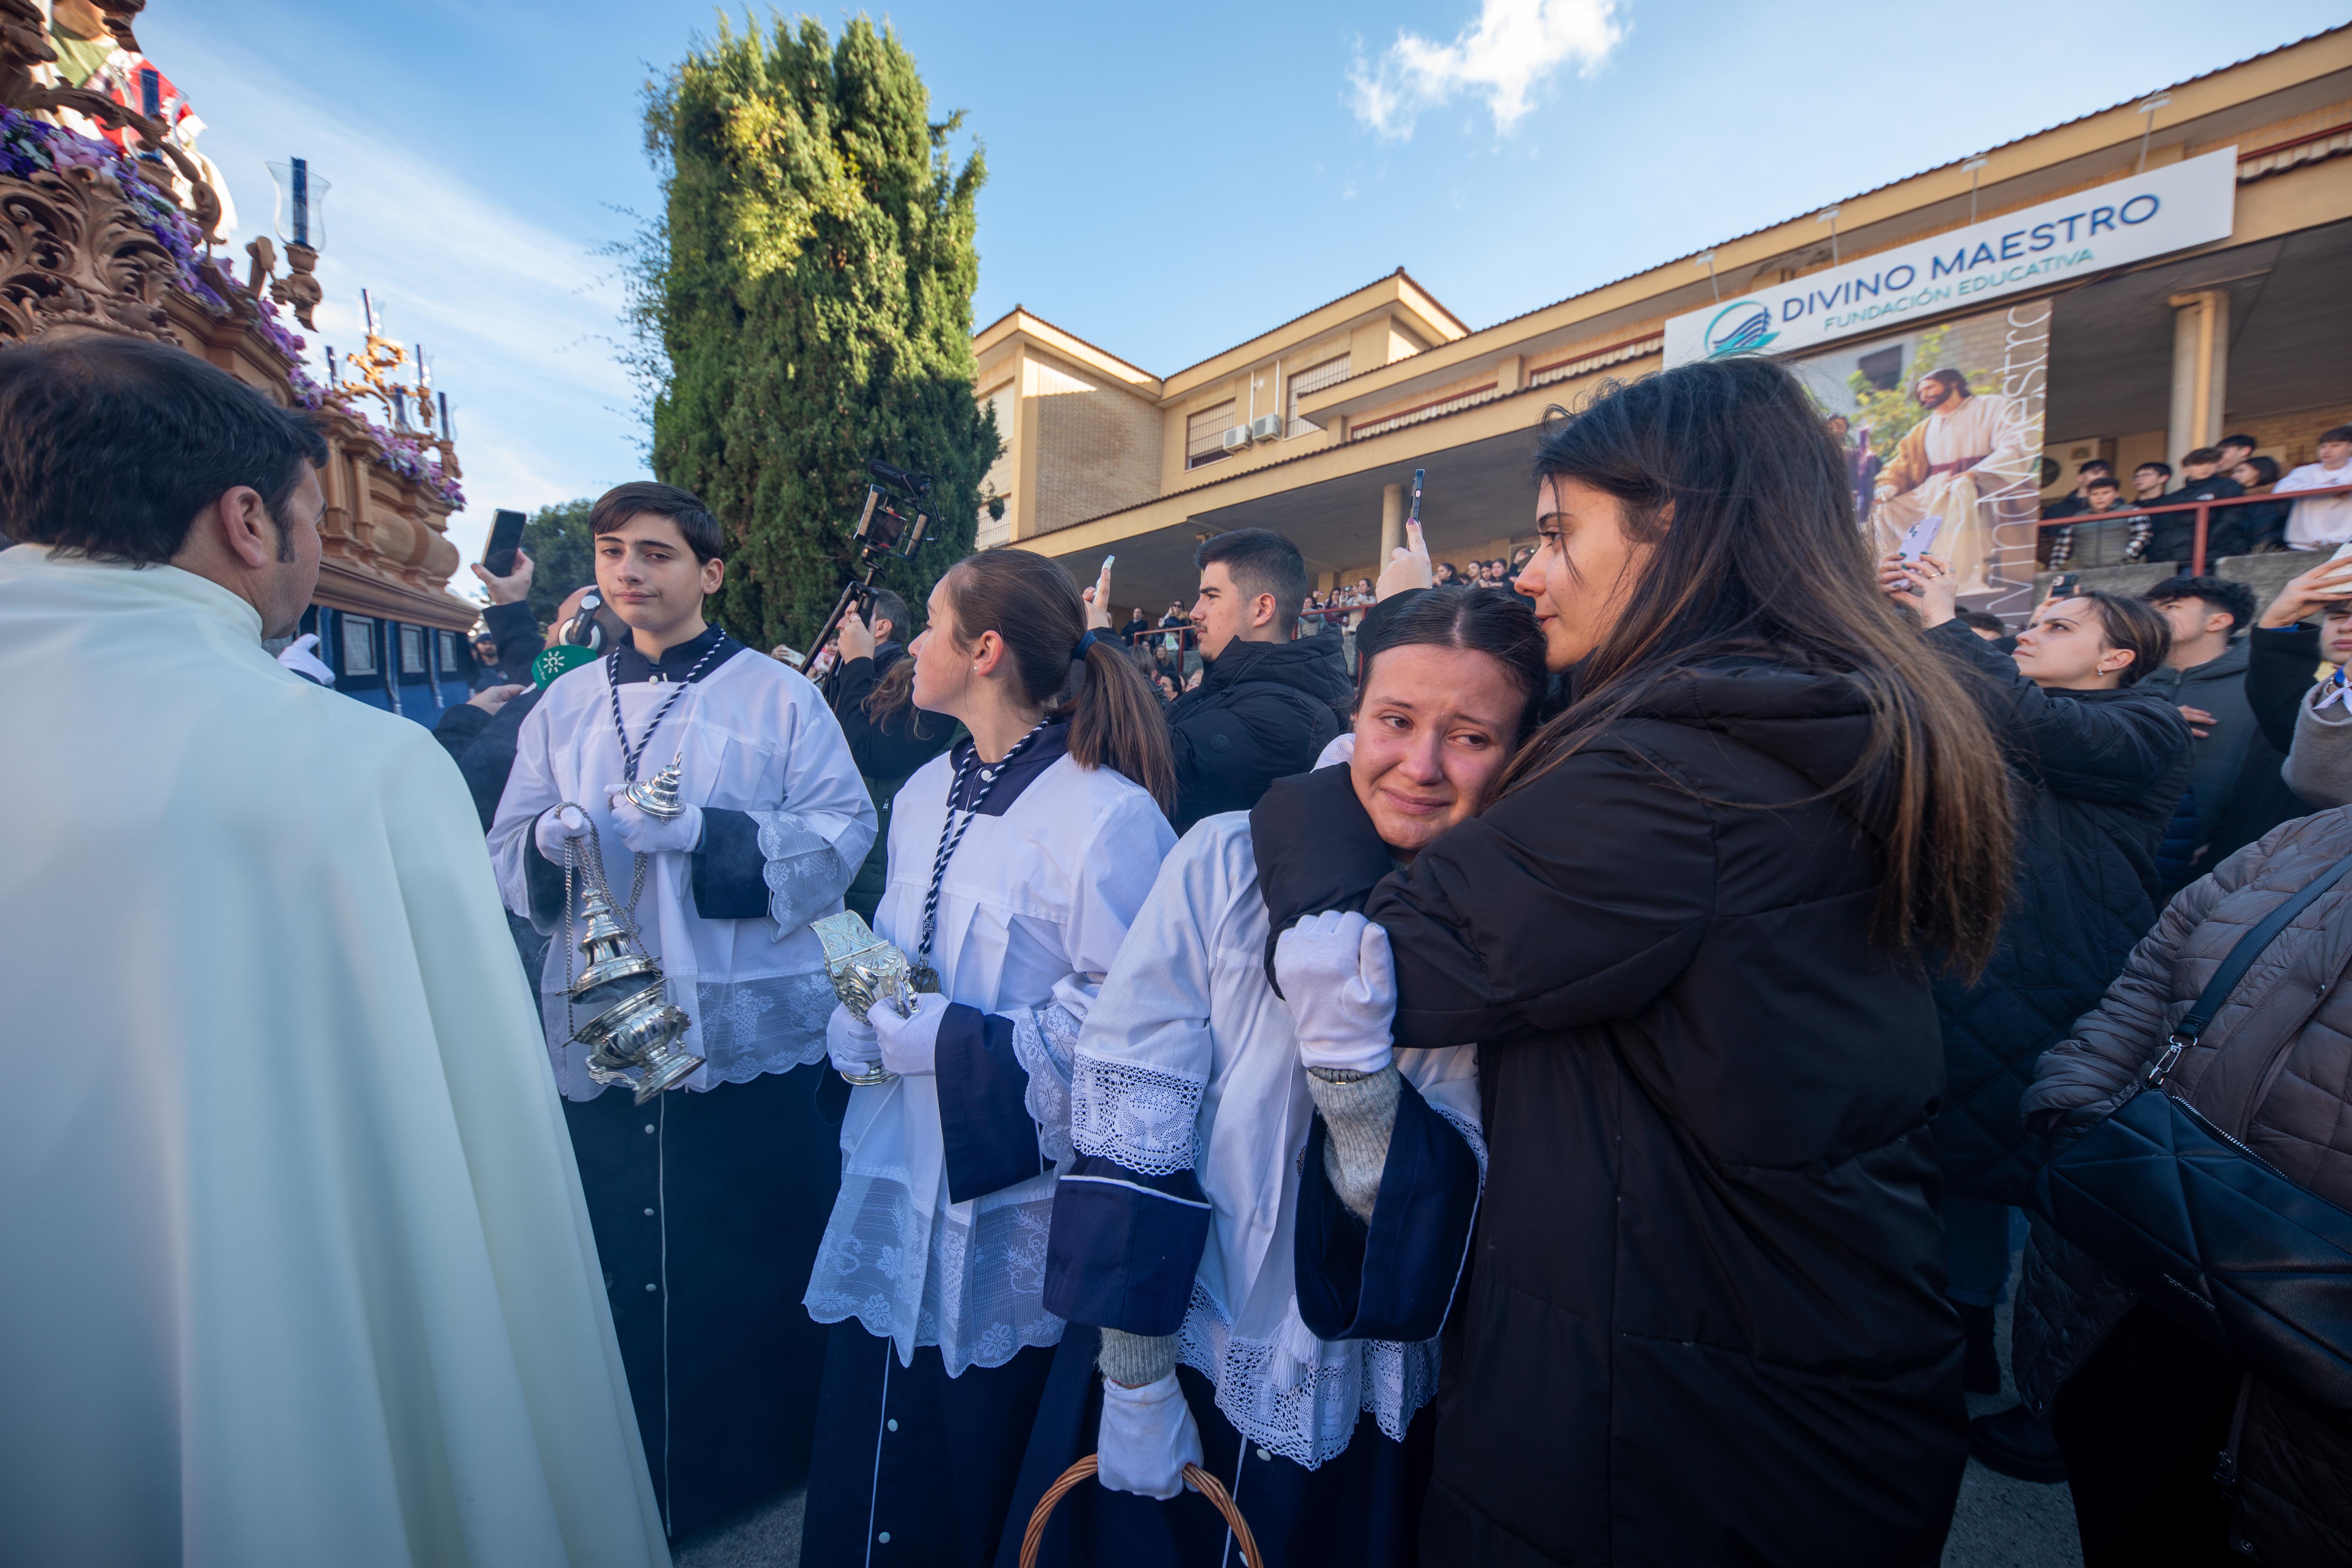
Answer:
[{"left": 941, "top": 550, "right": 1176, "bottom": 811}]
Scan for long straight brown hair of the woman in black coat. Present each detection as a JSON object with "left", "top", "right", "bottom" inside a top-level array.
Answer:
[{"left": 1503, "top": 357, "right": 2011, "bottom": 975}]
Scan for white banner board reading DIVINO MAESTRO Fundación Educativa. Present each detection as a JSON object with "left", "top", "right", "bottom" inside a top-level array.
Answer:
[{"left": 1665, "top": 148, "right": 2237, "bottom": 364}]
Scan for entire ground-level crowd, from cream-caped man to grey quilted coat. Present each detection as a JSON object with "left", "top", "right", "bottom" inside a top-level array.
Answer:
[{"left": 14, "top": 336, "right": 2352, "bottom": 1568}]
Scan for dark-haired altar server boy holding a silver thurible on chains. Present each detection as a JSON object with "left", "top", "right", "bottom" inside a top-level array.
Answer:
[{"left": 489, "top": 482, "right": 875, "bottom": 1535}]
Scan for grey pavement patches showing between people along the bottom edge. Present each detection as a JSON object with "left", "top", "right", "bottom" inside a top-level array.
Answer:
[{"left": 677, "top": 1279, "right": 2081, "bottom": 1568}]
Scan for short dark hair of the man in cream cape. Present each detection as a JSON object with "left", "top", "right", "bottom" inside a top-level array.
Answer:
[{"left": 0, "top": 334, "right": 327, "bottom": 567}]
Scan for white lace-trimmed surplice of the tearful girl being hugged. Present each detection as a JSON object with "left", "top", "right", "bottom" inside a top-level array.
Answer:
[{"left": 1070, "top": 811, "right": 1486, "bottom": 1469}]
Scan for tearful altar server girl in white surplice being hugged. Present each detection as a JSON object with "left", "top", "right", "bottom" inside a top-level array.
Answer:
[{"left": 997, "top": 588, "right": 1545, "bottom": 1568}]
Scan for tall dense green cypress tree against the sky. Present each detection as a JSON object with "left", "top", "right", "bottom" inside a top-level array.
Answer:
[{"left": 635, "top": 16, "right": 997, "bottom": 646}]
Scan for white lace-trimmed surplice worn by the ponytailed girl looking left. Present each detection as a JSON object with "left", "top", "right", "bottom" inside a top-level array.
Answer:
[{"left": 807, "top": 743, "right": 1176, "bottom": 1378}]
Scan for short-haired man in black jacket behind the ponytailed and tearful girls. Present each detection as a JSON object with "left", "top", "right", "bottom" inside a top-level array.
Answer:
[{"left": 1169, "top": 529, "right": 1348, "bottom": 832}]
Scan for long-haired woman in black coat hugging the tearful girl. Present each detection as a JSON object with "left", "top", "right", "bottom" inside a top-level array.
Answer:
[{"left": 1366, "top": 360, "right": 2009, "bottom": 1568}]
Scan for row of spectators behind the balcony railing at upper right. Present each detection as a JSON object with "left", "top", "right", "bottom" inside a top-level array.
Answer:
[{"left": 2039, "top": 426, "right": 2352, "bottom": 569}]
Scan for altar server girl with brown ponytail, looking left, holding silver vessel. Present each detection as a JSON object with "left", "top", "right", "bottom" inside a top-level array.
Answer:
[{"left": 802, "top": 550, "right": 1176, "bottom": 1568}]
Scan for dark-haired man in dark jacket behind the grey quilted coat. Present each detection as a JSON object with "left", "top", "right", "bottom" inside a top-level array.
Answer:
[{"left": 2140, "top": 576, "right": 2305, "bottom": 889}]
